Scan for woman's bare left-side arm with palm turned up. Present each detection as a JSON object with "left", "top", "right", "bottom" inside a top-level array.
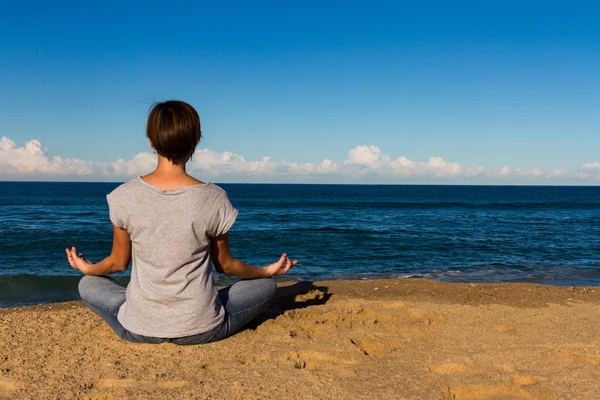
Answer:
[{"left": 65, "top": 225, "right": 131, "bottom": 275}]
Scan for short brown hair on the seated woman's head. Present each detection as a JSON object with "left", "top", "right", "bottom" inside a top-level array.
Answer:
[{"left": 146, "top": 100, "right": 202, "bottom": 165}]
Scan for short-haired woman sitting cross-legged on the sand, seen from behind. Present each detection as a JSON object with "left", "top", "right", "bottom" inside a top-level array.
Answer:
[{"left": 66, "top": 101, "right": 297, "bottom": 344}]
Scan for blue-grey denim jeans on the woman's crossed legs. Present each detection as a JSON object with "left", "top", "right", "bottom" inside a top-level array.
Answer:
[{"left": 79, "top": 275, "right": 277, "bottom": 345}]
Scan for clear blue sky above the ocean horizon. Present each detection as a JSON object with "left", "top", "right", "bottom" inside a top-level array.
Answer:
[{"left": 0, "top": 1, "right": 600, "bottom": 184}]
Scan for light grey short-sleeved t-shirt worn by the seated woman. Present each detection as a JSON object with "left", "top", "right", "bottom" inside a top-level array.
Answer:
[{"left": 106, "top": 177, "right": 238, "bottom": 338}]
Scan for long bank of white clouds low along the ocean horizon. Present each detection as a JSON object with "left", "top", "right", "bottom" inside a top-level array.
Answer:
[{"left": 0, "top": 137, "right": 600, "bottom": 185}]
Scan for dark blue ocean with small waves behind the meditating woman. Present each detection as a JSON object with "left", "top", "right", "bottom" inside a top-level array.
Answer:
[{"left": 0, "top": 182, "right": 600, "bottom": 307}]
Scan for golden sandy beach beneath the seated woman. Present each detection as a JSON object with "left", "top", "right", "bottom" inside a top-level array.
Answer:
[{"left": 0, "top": 279, "right": 600, "bottom": 400}]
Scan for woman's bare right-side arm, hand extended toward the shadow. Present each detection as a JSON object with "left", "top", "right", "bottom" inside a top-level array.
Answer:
[{"left": 210, "top": 233, "right": 298, "bottom": 278}]
